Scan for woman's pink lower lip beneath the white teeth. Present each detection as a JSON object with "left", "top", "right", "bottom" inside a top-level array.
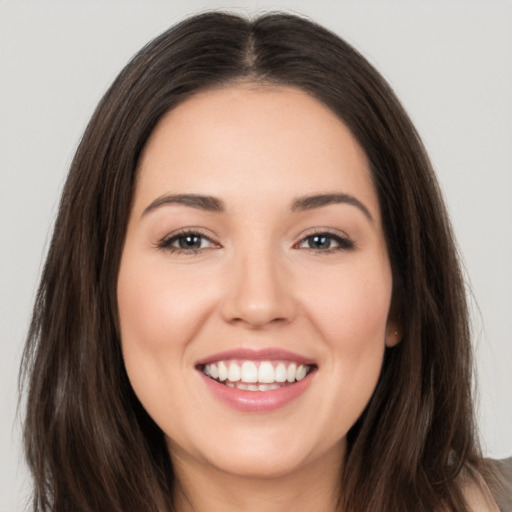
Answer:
[{"left": 200, "top": 370, "right": 315, "bottom": 412}]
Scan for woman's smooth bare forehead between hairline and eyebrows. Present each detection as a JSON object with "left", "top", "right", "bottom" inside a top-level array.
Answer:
[{"left": 136, "top": 84, "right": 378, "bottom": 216}]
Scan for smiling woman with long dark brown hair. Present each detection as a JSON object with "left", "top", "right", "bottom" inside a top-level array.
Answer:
[{"left": 20, "top": 9, "right": 508, "bottom": 512}]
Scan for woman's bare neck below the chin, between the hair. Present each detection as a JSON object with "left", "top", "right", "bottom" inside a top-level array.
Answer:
[{"left": 173, "top": 440, "right": 343, "bottom": 512}]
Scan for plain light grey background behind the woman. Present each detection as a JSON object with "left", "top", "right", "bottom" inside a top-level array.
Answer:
[{"left": 0, "top": 0, "right": 512, "bottom": 512}]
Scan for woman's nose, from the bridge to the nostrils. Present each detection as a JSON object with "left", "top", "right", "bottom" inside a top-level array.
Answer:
[{"left": 221, "top": 247, "right": 296, "bottom": 329}]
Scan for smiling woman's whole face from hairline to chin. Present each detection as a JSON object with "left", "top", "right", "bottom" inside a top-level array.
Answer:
[{"left": 118, "top": 85, "right": 398, "bottom": 477}]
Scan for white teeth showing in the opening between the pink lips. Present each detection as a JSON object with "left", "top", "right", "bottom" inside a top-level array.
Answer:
[{"left": 198, "top": 358, "right": 316, "bottom": 392}]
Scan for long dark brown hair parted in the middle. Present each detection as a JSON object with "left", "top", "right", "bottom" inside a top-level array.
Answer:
[{"left": 21, "top": 12, "right": 483, "bottom": 512}]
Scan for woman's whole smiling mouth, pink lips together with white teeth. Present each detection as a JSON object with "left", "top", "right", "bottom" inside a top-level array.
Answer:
[{"left": 196, "top": 349, "right": 317, "bottom": 412}]
